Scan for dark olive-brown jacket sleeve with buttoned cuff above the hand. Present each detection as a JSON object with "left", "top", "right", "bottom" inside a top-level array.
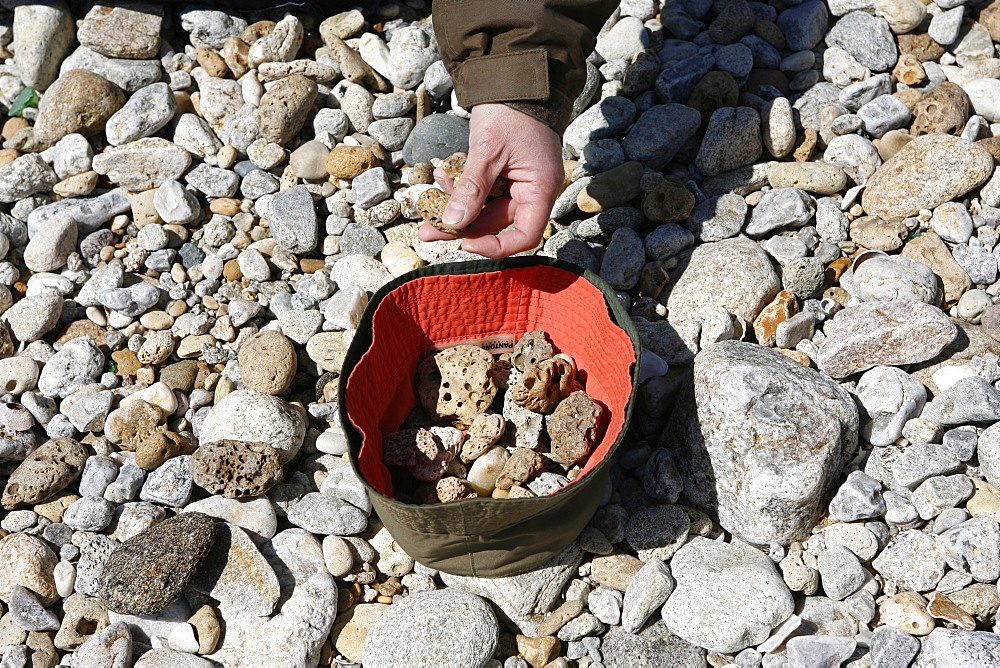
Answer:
[{"left": 433, "top": 0, "right": 618, "bottom": 134}]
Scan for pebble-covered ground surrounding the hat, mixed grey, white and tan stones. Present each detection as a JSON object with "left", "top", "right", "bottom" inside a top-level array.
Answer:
[{"left": 0, "top": 0, "right": 1000, "bottom": 668}]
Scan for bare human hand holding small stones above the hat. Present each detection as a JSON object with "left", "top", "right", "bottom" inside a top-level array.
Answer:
[{"left": 420, "top": 104, "right": 564, "bottom": 258}]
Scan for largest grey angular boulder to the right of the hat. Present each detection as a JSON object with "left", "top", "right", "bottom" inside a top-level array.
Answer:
[{"left": 663, "top": 341, "right": 858, "bottom": 545}]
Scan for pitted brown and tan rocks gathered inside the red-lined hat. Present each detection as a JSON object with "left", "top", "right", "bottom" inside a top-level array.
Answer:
[{"left": 382, "top": 332, "right": 604, "bottom": 503}]
